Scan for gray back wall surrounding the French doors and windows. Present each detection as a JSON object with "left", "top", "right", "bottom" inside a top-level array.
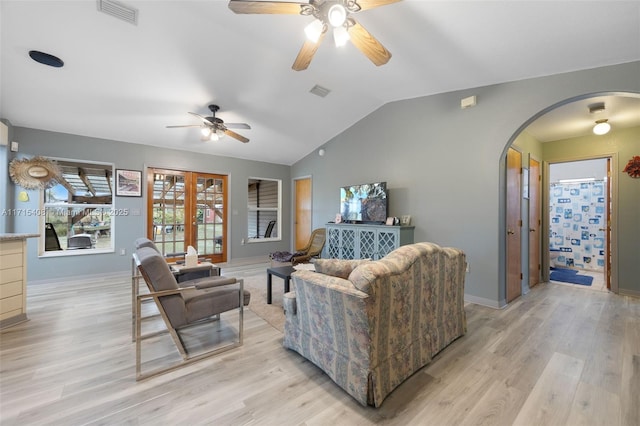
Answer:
[{"left": 2, "top": 127, "right": 291, "bottom": 281}]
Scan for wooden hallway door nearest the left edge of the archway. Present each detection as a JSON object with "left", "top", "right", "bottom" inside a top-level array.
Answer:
[{"left": 506, "top": 148, "right": 522, "bottom": 303}]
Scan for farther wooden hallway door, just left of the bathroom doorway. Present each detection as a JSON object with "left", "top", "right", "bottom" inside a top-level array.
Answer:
[{"left": 529, "top": 158, "right": 542, "bottom": 287}]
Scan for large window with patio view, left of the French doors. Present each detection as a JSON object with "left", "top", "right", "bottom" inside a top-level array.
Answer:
[{"left": 40, "top": 160, "right": 115, "bottom": 256}]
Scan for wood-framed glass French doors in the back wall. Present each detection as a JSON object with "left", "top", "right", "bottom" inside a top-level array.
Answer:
[{"left": 147, "top": 168, "right": 227, "bottom": 263}]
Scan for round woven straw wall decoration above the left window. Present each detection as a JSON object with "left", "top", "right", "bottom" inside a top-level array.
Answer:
[{"left": 9, "top": 157, "right": 61, "bottom": 189}]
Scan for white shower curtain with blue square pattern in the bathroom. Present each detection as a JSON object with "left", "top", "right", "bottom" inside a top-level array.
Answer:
[{"left": 549, "top": 181, "right": 607, "bottom": 271}]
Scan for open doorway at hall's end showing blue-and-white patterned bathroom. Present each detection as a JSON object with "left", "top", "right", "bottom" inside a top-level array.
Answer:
[{"left": 547, "top": 157, "right": 611, "bottom": 291}]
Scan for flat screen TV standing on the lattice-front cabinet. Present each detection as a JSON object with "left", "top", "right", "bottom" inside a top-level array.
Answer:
[{"left": 340, "top": 182, "right": 389, "bottom": 223}]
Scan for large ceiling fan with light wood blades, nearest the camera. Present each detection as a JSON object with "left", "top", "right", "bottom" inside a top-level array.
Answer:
[{"left": 229, "top": 0, "right": 401, "bottom": 71}]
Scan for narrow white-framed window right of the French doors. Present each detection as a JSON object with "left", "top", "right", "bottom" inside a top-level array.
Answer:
[{"left": 247, "top": 178, "right": 282, "bottom": 242}]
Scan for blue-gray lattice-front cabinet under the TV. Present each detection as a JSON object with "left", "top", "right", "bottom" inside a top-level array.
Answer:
[{"left": 326, "top": 223, "right": 415, "bottom": 260}]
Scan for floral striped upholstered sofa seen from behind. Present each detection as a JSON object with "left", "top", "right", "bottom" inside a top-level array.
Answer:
[{"left": 283, "top": 243, "right": 466, "bottom": 407}]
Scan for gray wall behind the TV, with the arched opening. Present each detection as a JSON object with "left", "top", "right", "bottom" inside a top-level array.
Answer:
[{"left": 291, "top": 62, "right": 640, "bottom": 306}]
